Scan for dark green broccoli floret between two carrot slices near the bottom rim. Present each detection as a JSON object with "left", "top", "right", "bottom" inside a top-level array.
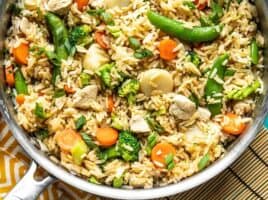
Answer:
[{"left": 117, "top": 131, "right": 141, "bottom": 161}]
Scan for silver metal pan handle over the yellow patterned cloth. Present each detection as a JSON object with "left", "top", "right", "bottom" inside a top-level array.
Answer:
[{"left": 4, "top": 161, "right": 55, "bottom": 200}]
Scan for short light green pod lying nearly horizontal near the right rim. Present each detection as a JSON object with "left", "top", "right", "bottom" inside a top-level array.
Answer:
[{"left": 227, "top": 80, "right": 261, "bottom": 100}]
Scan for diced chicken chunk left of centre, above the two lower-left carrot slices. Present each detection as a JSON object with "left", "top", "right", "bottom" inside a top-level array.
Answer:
[{"left": 73, "top": 85, "right": 98, "bottom": 109}]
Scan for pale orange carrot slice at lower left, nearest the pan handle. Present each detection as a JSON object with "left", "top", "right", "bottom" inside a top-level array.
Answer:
[{"left": 54, "top": 129, "right": 82, "bottom": 152}]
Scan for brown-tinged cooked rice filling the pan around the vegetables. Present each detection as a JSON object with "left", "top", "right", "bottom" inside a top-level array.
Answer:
[{"left": 4, "top": 0, "right": 264, "bottom": 189}]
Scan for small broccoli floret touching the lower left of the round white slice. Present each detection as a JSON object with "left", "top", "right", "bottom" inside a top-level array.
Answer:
[{"left": 118, "top": 79, "right": 140, "bottom": 104}]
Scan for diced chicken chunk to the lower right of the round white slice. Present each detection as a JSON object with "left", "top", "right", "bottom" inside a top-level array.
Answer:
[{"left": 169, "top": 95, "right": 196, "bottom": 120}]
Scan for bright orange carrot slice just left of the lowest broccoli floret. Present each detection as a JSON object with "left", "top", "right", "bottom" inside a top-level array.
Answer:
[{"left": 96, "top": 127, "right": 118, "bottom": 147}]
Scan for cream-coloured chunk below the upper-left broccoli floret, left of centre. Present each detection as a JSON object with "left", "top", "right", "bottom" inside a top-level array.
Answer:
[{"left": 83, "top": 44, "right": 109, "bottom": 72}]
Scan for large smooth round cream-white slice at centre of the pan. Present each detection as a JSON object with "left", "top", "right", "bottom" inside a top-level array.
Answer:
[{"left": 140, "top": 69, "right": 173, "bottom": 96}]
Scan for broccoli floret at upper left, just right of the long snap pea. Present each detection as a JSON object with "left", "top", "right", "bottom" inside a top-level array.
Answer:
[{"left": 69, "top": 25, "right": 92, "bottom": 46}]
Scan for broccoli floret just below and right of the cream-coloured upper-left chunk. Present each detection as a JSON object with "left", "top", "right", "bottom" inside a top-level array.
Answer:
[{"left": 97, "top": 63, "right": 123, "bottom": 89}]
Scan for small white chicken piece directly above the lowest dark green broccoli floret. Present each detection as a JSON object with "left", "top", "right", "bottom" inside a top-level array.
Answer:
[{"left": 130, "top": 115, "right": 151, "bottom": 133}]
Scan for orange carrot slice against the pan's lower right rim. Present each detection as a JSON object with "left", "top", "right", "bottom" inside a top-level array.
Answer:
[{"left": 222, "top": 113, "right": 246, "bottom": 135}]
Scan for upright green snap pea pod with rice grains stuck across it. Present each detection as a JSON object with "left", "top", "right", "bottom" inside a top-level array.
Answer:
[{"left": 205, "top": 54, "right": 229, "bottom": 116}]
